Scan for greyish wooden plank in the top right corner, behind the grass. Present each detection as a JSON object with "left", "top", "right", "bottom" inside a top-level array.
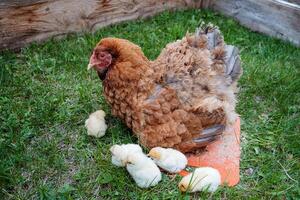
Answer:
[{"left": 210, "top": 0, "right": 300, "bottom": 46}]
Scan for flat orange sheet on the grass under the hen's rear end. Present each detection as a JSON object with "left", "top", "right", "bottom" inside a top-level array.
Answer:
[{"left": 179, "top": 118, "right": 241, "bottom": 186}]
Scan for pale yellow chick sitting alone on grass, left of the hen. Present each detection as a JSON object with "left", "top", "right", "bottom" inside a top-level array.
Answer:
[{"left": 85, "top": 110, "right": 107, "bottom": 137}]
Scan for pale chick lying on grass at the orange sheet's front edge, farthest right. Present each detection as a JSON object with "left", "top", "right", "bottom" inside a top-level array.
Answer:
[{"left": 178, "top": 167, "right": 221, "bottom": 192}]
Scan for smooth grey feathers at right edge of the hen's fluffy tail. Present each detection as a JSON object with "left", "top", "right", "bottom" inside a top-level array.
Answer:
[{"left": 225, "top": 45, "right": 242, "bottom": 82}]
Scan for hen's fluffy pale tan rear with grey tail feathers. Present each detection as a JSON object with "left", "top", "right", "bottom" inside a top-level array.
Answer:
[{"left": 153, "top": 28, "right": 242, "bottom": 121}]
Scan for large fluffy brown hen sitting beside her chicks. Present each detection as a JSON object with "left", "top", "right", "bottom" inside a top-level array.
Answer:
[{"left": 88, "top": 27, "right": 242, "bottom": 152}]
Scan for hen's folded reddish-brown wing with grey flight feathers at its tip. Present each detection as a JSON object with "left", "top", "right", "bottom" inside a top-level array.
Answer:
[{"left": 138, "top": 85, "right": 225, "bottom": 152}]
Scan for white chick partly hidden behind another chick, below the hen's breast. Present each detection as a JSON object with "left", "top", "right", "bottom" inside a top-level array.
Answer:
[{"left": 110, "top": 144, "right": 143, "bottom": 167}]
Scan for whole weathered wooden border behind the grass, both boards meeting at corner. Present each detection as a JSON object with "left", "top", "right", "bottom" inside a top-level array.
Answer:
[{"left": 0, "top": 0, "right": 300, "bottom": 51}]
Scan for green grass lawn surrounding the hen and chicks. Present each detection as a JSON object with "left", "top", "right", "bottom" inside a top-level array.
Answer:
[{"left": 0, "top": 10, "right": 300, "bottom": 199}]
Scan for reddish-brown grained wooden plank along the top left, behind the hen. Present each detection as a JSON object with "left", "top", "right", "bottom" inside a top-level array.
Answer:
[{"left": 0, "top": 0, "right": 207, "bottom": 51}]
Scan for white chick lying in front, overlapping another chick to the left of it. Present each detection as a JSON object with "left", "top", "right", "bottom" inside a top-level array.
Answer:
[{"left": 126, "top": 153, "right": 161, "bottom": 188}]
